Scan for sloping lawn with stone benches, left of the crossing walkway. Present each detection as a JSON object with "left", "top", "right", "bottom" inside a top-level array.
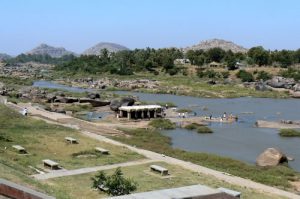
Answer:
[{"left": 0, "top": 105, "right": 142, "bottom": 174}]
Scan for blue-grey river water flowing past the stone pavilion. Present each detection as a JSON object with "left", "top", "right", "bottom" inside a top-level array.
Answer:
[{"left": 34, "top": 81, "right": 300, "bottom": 171}]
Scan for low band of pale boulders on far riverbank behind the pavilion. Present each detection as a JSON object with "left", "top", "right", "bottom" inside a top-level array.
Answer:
[{"left": 70, "top": 78, "right": 159, "bottom": 89}]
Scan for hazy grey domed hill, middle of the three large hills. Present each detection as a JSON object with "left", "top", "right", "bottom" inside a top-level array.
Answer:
[{"left": 82, "top": 42, "right": 129, "bottom": 55}]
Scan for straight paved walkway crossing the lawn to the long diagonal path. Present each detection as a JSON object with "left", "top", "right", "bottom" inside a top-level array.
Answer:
[{"left": 33, "top": 159, "right": 154, "bottom": 180}]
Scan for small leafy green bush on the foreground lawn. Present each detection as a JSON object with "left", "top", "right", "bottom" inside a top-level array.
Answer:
[{"left": 92, "top": 167, "right": 137, "bottom": 196}]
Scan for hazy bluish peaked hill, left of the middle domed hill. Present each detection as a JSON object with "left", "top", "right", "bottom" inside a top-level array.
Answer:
[{"left": 26, "top": 44, "right": 75, "bottom": 57}]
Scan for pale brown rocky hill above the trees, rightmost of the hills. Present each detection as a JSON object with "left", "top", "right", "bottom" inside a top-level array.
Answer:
[{"left": 184, "top": 39, "right": 248, "bottom": 53}]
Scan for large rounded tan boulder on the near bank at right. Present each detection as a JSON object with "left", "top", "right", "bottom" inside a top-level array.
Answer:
[{"left": 256, "top": 148, "right": 288, "bottom": 167}]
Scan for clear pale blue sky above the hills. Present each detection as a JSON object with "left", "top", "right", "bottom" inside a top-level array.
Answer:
[{"left": 0, "top": 0, "right": 300, "bottom": 55}]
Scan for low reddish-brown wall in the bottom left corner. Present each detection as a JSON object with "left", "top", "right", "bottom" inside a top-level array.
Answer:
[{"left": 0, "top": 179, "right": 55, "bottom": 199}]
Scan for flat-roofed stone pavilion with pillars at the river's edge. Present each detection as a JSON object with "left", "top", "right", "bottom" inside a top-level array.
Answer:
[{"left": 118, "top": 105, "right": 163, "bottom": 119}]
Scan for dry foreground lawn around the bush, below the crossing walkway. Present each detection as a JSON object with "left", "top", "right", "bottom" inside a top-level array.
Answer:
[{"left": 46, "top": 162, "right": 282, "bottom": 199}]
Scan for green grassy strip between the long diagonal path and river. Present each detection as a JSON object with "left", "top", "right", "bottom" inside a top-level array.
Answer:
[{"left": 112, "top": 129, "right": 300, "bottom": 189}]
